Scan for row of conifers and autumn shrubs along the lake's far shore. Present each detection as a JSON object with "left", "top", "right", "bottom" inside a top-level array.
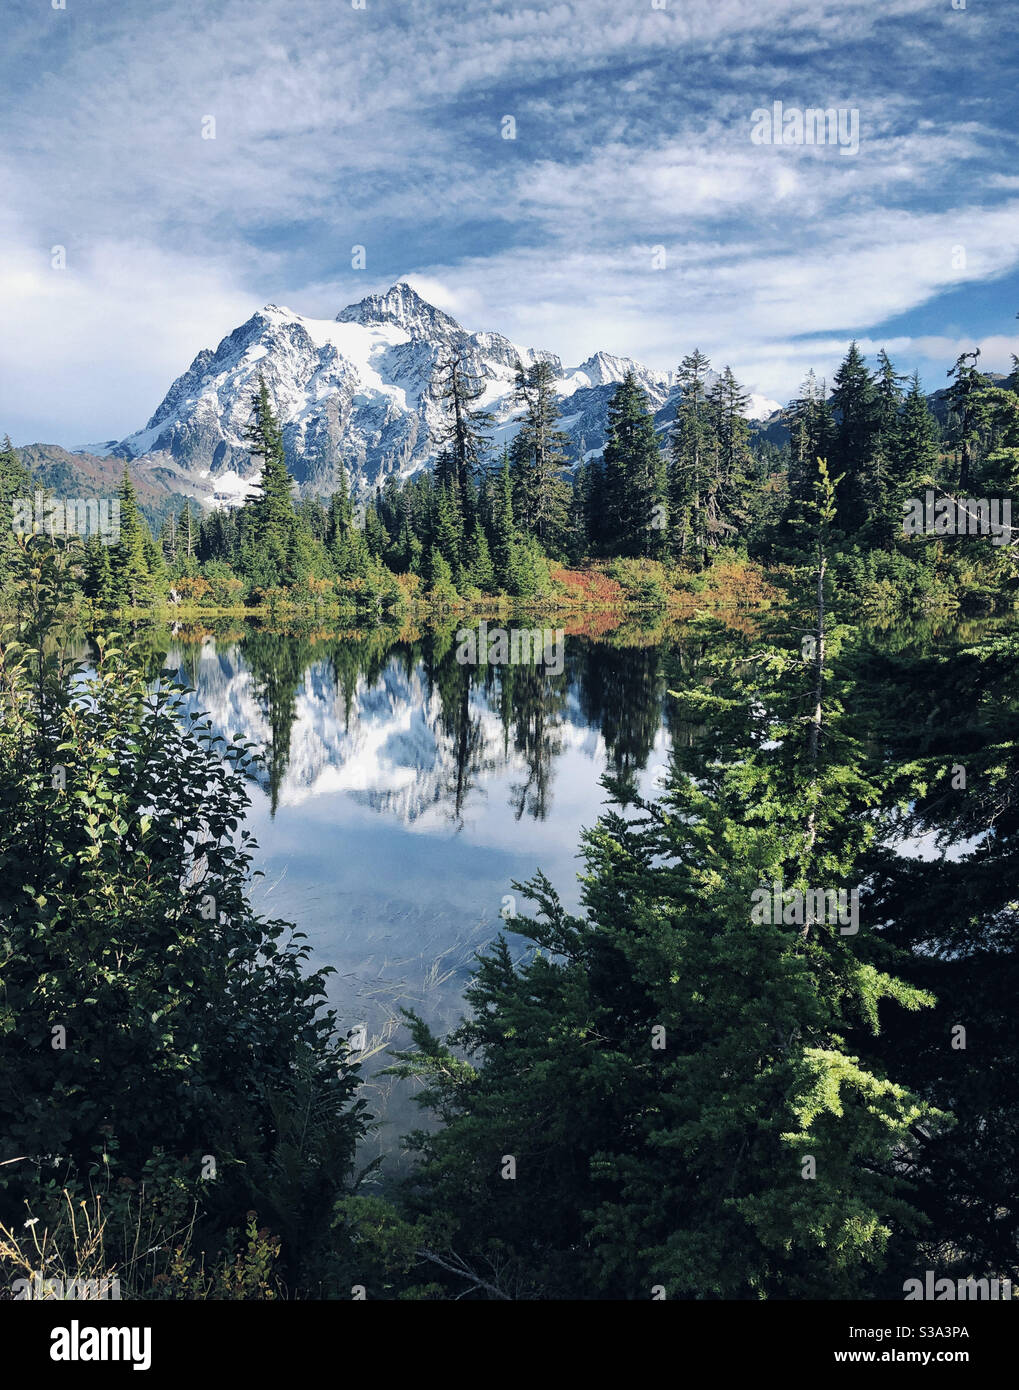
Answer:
[{"left": 0, "top": 333, "right": 1019, "bottom": 614}]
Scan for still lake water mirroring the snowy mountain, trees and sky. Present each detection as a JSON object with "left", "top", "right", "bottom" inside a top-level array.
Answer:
[{"left": 165, "top": 630, "right": 669, "bottom": 1167}]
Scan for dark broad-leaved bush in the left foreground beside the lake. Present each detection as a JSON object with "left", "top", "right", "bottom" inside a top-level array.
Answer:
[{"left": 0, "top": 539, "right": 364, "bottom": 1278}]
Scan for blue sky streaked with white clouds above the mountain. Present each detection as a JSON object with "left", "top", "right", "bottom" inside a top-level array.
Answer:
[{"left": 0, "top": 0, "right": 1019, "bottom": 445}]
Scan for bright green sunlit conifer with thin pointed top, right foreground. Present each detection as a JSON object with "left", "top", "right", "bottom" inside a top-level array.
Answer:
[{"left": 395, "top": 461, "right": 937, "bottom": 1300}]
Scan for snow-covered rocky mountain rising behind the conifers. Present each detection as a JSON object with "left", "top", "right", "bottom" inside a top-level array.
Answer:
[{"left": 113, "top": 282, "right": 778, "bottom": 505}]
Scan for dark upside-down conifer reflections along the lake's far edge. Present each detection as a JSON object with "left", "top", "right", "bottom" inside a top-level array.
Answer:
[{"left": 202, "top": 628, "right": 683, "bottom": 821}]
